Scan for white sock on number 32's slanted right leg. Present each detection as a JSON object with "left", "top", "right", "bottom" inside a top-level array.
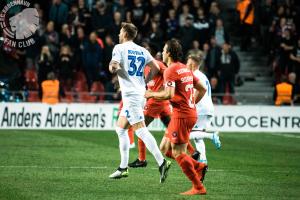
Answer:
[{"left": 135, "top": 127, "right": 164, "bottom": 166}]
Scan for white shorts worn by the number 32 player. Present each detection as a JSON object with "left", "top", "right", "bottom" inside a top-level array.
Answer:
[{"left": 120, "top": 95, "right": 146, "bottom": 125}]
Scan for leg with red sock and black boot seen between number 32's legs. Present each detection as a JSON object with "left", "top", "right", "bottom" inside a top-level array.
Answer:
[{"left": 128, "top": 115, "right": 154, "bottom": 168}]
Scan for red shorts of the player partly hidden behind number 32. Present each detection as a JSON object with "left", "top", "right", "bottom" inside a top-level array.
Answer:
[{"left": 144, "top": 102, "right": 171, "bottom": 118}]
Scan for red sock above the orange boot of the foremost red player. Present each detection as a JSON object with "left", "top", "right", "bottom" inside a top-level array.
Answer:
[{"left": 176, "top": 153, "right": 203, "bottom": 190}]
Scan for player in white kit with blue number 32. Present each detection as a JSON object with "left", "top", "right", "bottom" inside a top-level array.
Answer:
[{"left": 109, "top": 23, "right": 171, "bottom": 183}]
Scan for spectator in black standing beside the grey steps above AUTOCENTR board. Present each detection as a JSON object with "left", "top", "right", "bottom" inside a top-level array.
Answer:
[{"left": 218, "top": 43, "right": 240, "bottom": 94}]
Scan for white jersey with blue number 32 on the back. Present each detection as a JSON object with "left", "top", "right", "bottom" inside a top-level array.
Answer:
[{"left": 112, "top": 41, "right": 154, "bottom": 96}]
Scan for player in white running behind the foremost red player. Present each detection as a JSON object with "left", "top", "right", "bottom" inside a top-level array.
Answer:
[{"left": 187, "top": 55, "right": 221, "bottom": 164}]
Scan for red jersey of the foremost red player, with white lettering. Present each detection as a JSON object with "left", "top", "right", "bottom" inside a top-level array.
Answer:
[{"left": 164, "top": 62, "right": 199, "bottom": 118}]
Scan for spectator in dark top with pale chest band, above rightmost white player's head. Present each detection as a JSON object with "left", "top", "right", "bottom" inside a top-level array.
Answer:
[{"left": 193, "top": 7, "right": 210, "bottom": 46}]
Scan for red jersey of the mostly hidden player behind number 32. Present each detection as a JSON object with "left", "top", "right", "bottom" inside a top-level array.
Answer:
[{"left": 144, "top": 60, "right": 168, "bottom": 103}]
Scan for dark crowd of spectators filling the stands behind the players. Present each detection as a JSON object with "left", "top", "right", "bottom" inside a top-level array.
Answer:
[{"left": 0, "top": 0, "right": 300, "bottom": 103}]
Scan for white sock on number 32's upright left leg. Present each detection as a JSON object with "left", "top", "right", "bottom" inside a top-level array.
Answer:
[{"left": 116, "top": 127, "right": 130, "bottom": 168}]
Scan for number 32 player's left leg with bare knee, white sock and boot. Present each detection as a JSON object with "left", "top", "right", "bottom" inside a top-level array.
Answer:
[{"left": 109, "top": 115, "right": 129, "bottom": 179}]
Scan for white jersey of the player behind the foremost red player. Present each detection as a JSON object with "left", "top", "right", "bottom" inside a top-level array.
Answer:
[{"left": 193, "top": 70, "right": 214, "bottom": 116}]
